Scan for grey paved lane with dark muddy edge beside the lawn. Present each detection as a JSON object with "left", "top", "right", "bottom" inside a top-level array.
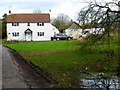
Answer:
[{"left": 0, "top": 46, "right": 52, "bottom": 88}]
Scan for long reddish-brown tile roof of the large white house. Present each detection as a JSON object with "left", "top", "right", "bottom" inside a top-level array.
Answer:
[{"left": 7, "top": 13, "right": 50, "bottom": 23}]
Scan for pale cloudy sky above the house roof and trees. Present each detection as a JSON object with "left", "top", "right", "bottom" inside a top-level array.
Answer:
[{"left": 0, "top": 0, "right": 118, "bottom": 20}]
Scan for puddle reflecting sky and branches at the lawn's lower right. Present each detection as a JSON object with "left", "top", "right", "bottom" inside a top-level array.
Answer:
[{"left": 79, "top": 73, "right": 120, "bottom": 90}]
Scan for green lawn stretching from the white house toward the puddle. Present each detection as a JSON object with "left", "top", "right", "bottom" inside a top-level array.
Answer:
[{"left": 6, "top": 41, "right": 118, "bottom": 87}]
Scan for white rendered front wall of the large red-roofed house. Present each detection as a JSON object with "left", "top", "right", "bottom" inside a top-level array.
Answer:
[{"left": 7, "top": 23, "right": 59, "bottom": 41}]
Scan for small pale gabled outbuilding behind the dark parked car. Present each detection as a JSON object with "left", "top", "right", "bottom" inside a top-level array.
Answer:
[{"left": 64, "top": 22, "right": 82, "bottom": 39}]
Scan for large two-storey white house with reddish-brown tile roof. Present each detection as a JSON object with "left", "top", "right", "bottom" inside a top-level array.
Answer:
[{"left": 7, "top": 13, "right": 59, "bottom": 41}]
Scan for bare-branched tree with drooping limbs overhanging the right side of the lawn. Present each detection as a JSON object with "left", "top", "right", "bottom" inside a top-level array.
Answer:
[{"left": 77, "top": 0, "right": 120, "bottom": 76}]
